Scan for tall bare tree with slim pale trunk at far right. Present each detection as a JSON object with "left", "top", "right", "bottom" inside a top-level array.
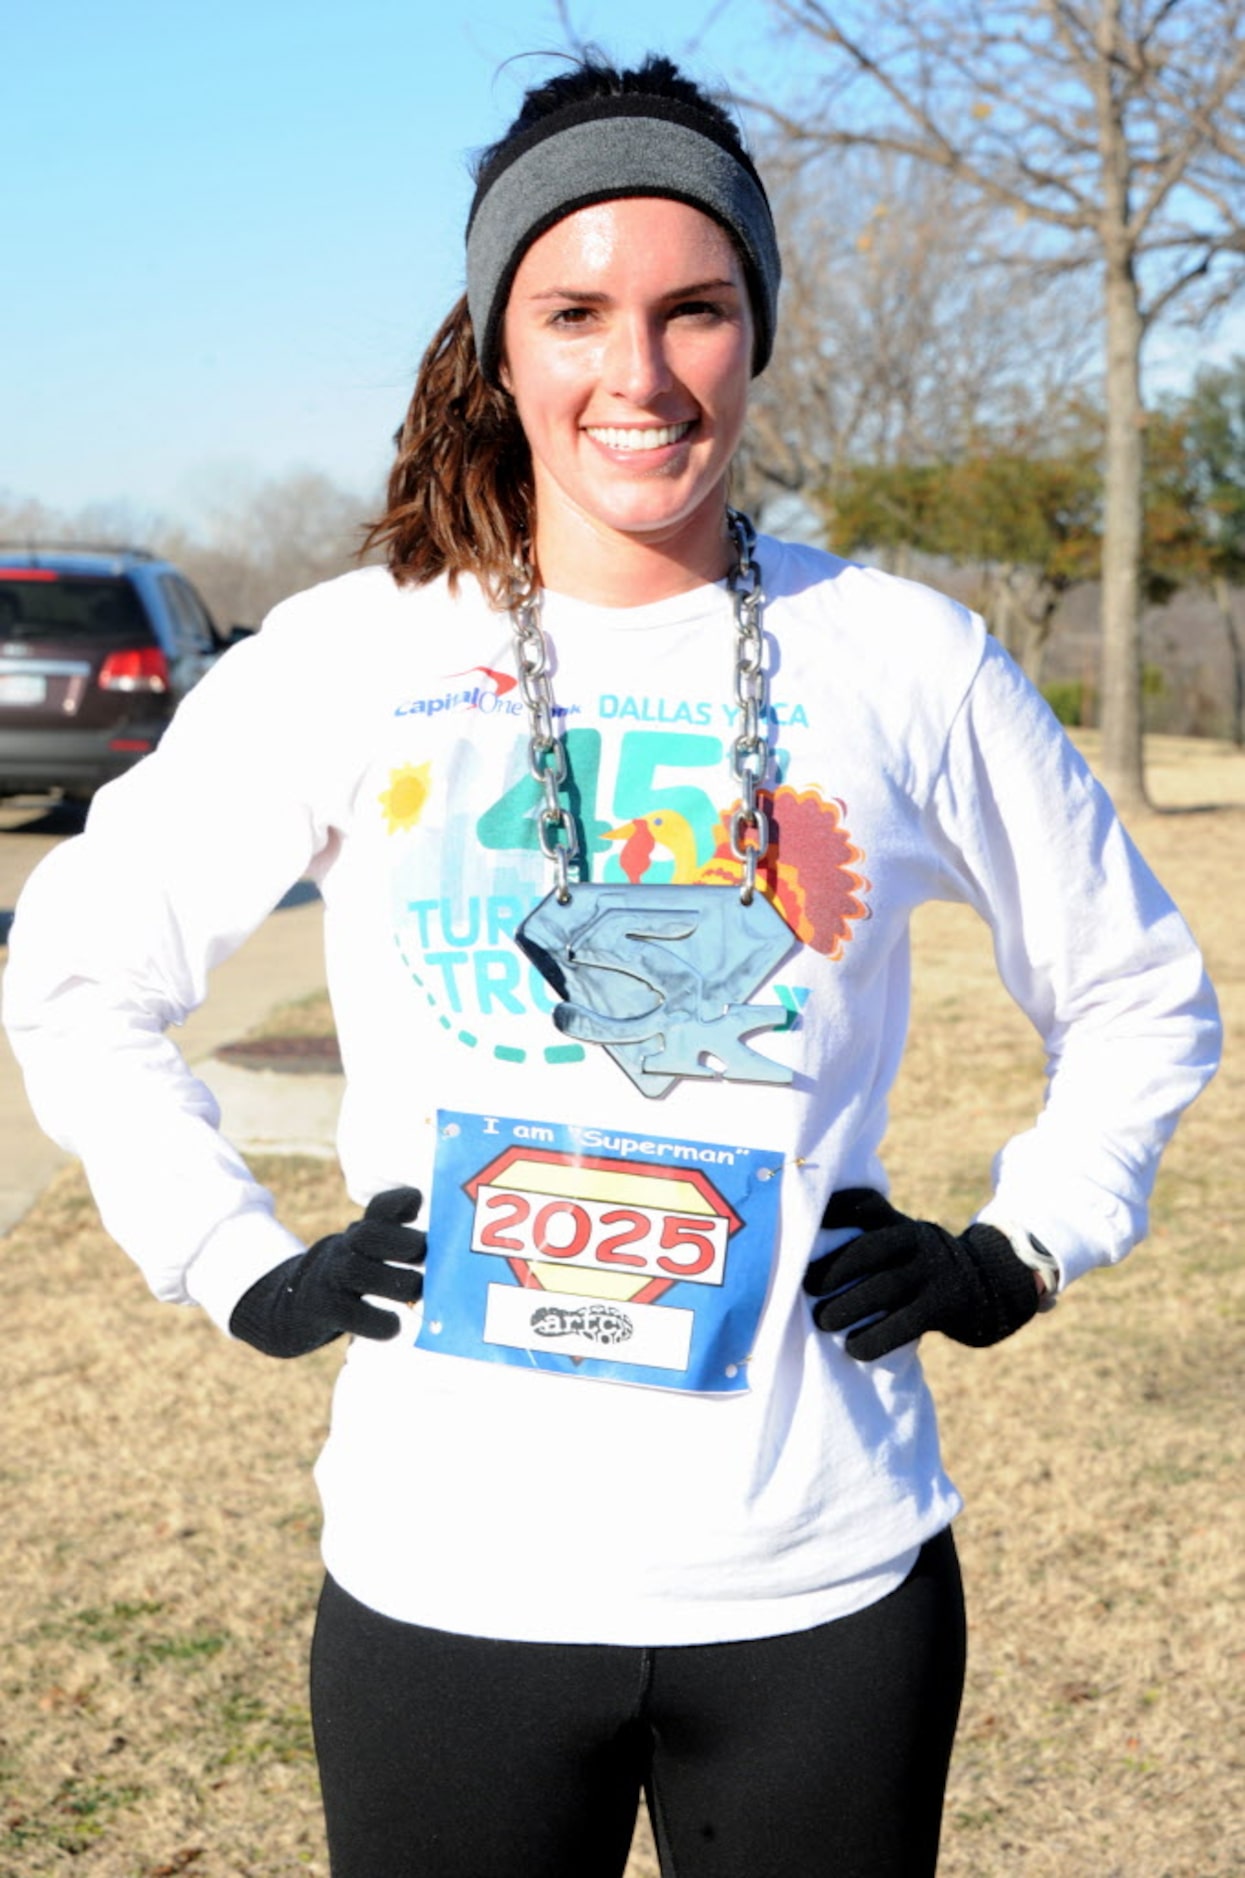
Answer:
[{"left": 753, "top": 0, "right": 1245, "bottom": 808}]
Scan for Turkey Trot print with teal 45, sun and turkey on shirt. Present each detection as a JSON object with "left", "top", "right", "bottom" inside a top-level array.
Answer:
[{"left": 384, "top": 706, "right": 869, "bottom": 1093}]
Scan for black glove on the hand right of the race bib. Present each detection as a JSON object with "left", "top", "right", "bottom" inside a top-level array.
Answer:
[{"left": 804, "top": 1187, "right": 1038, "bottom": 1363}]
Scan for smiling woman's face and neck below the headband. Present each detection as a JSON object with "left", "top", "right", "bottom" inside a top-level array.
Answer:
[{"left": 501, "top": 197, "right": 753, "bottom": 586}]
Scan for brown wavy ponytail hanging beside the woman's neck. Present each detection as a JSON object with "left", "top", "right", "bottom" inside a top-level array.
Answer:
[{"left": 362, "top": 293, "right": 533, "bottom": 607}]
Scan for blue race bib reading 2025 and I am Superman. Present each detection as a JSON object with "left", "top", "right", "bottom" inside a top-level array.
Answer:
[{"left": 415, "top": 1110, "right": 783, "bottom": 1395}]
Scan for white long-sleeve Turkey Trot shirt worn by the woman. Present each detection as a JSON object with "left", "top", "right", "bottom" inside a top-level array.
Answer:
[{"left": 6, "top": 537, "right": 1219, "bottom": 1643}]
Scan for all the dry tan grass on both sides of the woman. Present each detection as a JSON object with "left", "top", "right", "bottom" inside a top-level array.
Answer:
[{"left": 0, "top": 740, "right": 1245, "bottom": 1878}]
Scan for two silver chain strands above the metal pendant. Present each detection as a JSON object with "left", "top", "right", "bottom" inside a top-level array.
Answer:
[{"left": 511, "top": 509, "right": 770, "bottom": 905}]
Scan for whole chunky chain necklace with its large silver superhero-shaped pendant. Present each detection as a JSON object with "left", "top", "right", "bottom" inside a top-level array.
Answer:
[{"left": 511, "top": 509, "right": 798, "bottom": 1097}]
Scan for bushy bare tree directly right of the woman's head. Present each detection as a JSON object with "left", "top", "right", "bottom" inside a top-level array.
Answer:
[{"left": 740, "top": 141, "right": 1091, "bottom": 511}]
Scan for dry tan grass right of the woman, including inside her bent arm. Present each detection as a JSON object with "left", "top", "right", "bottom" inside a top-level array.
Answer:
[{"left": 888, "top": 740, "right": 1245, "bottom": 1878}]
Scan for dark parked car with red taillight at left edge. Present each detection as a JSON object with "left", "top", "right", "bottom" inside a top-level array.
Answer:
[{"left": 0, "top": 543, "right": 227, "bottom": 800}]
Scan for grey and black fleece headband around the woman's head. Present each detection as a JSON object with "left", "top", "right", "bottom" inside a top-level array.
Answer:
[{"left": 468, "top": 92, "right": 781, "bottom": 385}]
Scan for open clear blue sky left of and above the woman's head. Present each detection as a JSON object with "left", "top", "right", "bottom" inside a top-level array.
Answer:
[{"left": 0, "top": 0, "right": 781, "bottom": 524}]
